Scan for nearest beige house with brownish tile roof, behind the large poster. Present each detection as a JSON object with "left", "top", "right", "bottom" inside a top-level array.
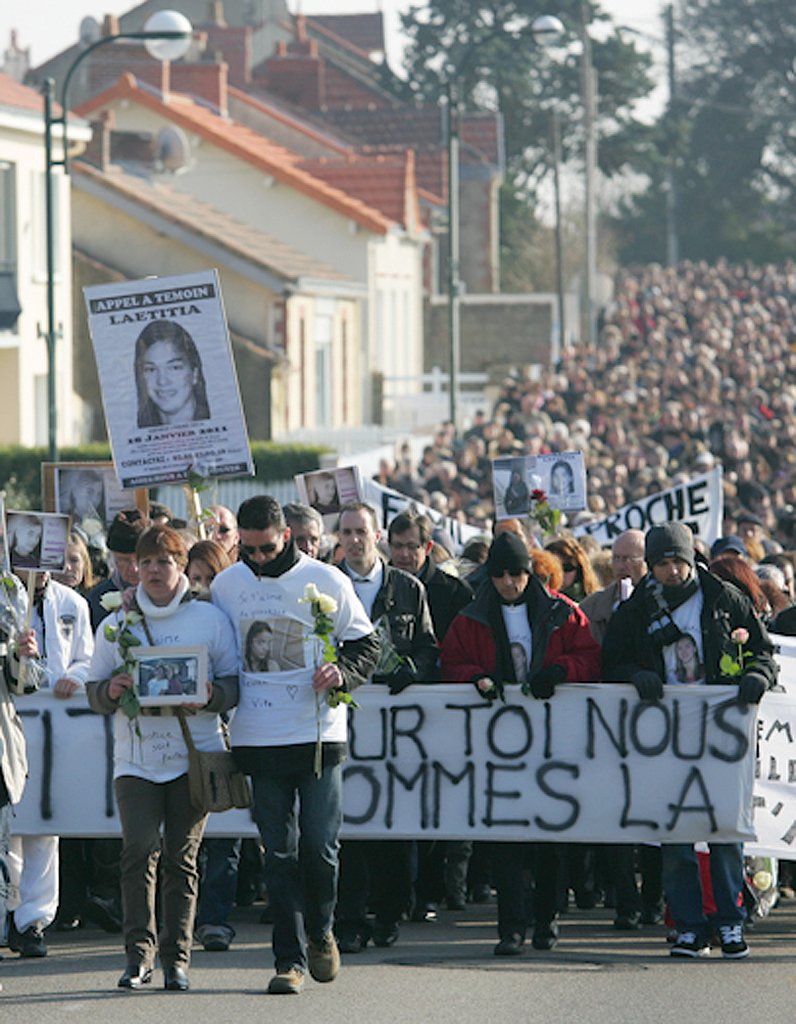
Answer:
[{"left": 73, "top": 125, "right": 365, "bottom": 439}]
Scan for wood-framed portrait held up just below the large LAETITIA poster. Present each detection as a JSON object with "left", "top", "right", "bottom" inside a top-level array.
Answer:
[{"left": 41, "top": 462, "right": 150, "bottom": 537}]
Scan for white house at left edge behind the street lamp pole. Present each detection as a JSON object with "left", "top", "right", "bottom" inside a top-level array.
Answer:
[{"left": 0, "top": 72, "right": 90, "bottom": 445}]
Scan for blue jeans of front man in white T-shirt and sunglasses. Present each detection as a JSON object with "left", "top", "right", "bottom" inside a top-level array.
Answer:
[{"left": 252, "top": 764, "right": 342, "bottom": 971}]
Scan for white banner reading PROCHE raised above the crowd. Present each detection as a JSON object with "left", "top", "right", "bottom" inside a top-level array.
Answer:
[{"left": 573, "top": 466, "right": 724, "bottom": 545}]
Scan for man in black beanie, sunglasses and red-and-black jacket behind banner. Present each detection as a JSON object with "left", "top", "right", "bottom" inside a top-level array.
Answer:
[{"left": 441, "top": 534, "right": 600, "bottom": 956}]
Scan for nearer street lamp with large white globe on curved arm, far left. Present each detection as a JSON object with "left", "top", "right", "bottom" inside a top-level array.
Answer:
[{"left": 40, "top": 10, "right": 193, "bottom": 462}]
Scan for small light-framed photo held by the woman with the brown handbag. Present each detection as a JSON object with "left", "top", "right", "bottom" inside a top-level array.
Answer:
[{"left": 133, "top": 645, "right": 210, "bottom": 708}]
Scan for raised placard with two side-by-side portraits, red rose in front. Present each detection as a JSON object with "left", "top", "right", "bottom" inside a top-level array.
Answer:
[{"left": 492, "top": 452, "right": 586, "bottom": 519}]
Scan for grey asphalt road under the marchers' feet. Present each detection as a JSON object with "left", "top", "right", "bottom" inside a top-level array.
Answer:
[{"left": 0, "top": 902, "right": 796, "bottom": 1024}]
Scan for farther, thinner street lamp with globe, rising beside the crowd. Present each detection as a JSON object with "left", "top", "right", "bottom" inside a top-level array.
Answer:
[{"left": 445, "top": 14, "right": 564, "bottom": 427}]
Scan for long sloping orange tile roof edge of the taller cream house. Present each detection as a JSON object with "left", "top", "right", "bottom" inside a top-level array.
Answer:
[{"left": 77, "top": 74, "right": 390, "bottom": 234}]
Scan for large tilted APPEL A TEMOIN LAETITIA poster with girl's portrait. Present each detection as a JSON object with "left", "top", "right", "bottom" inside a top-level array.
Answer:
[{"left": 83, "top": 270, "right": 253, "bottom": 488}]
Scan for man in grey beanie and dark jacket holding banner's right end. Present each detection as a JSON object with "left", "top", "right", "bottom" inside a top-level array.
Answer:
[{"left": 602, "top": 522, "right": 778, "bottom": 959}]
